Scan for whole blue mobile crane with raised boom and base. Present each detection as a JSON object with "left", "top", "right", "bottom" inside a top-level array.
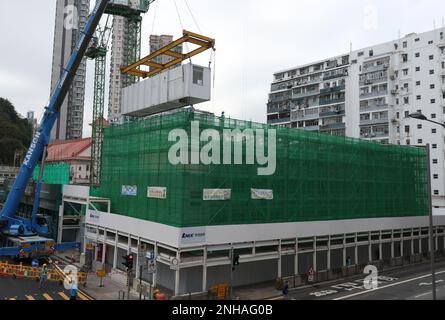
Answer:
[{"left": 0, "top": 0, "right": 110, "bottom": 258}]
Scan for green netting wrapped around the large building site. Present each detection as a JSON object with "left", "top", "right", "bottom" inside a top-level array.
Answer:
[{"left": 91, "top": 112, "right": 428, "bottom": 227}]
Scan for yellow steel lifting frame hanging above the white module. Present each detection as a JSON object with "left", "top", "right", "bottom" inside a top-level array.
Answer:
[{"left": 121, "top": 30, "right": 215, "bottom": 78}]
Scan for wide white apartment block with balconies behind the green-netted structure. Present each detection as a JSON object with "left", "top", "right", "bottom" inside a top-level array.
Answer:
[{"left": 267, "top": 28, "right": 445, "bottom": 207}]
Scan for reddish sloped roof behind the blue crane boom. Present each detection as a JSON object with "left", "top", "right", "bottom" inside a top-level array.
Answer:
[{"left": 46, "top": 138, "right": 92, "bottom": 162}]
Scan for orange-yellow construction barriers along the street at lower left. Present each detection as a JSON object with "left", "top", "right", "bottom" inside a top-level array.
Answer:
[{"left": 0, "top": 262, "right": 87, "bottom": 285}]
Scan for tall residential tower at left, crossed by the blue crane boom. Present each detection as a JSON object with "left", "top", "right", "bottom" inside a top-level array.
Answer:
[{"left": 51, "top": 0, "right": 90, "bottom": 140}]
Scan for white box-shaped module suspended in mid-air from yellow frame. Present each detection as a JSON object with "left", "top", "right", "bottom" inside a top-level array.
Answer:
[{"left": 121, "top": 64, "right": 211, "bottom": 117}]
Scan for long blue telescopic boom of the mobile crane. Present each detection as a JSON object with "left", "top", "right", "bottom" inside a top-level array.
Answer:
[{"left": 0, "top": 0, "right": 110, "bottom": 235}]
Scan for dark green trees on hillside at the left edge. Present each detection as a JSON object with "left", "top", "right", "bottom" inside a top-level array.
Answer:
[{"left": 0, "top": 98, "right": 32, "bottom": 166}]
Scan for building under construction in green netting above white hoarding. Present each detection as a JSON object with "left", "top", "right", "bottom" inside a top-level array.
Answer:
[{"left": 78, "top": 111, "right": 445, "bottom": 295}]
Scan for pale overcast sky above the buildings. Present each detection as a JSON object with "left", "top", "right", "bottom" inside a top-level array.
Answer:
[{"left": 0, "top": 0, "right": 445, "bottom": 136}]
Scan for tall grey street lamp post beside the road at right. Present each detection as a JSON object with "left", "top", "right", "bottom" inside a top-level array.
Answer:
[{"left": 409, "top": 112, "right": 438, "bottom": 300}]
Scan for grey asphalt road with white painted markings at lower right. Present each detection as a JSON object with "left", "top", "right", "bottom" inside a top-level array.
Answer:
[{"left": 289, "top": 263, "right": 445, "bottom": 300}]
